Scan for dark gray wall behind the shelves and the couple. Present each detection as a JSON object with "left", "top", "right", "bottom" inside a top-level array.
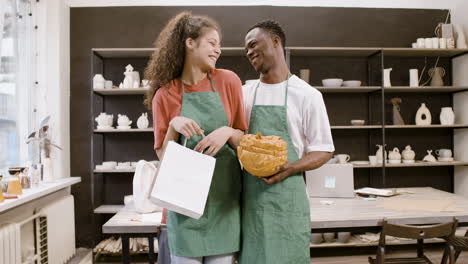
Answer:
[{"left": 71, "top": 6, "right": 452, "bottom": 250}]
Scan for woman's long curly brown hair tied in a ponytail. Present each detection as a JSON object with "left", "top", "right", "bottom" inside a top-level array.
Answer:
[{"left": 144, "top": 12, "right": 221, "bottom": 110}]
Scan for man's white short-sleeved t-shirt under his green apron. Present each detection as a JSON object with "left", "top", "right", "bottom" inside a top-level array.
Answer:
[{"left": 242, "top": 75, "right": 335, "bottom": 158}]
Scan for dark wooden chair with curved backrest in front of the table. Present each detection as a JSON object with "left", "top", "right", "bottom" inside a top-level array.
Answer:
[{"left": 369, "top": 219, "right": 458, "bottom": 264}]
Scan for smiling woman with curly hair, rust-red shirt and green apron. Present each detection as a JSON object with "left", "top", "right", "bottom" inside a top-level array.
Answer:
[{"left": 145, "top": 12, "right": 247, "bottom": 264}]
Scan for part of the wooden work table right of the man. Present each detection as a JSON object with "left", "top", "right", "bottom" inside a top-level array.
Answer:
[{"left": 310, "top": 187, "right": 468, "bottom": 230}]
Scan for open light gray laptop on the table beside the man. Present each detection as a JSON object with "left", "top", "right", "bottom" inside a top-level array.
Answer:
[{"left": 306, "top": 163, "right": 354, "bottom": 198}]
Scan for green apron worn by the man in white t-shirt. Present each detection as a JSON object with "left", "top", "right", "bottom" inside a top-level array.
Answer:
[{"left": 240, "top": 74, "right": 310, "bottom": 264}]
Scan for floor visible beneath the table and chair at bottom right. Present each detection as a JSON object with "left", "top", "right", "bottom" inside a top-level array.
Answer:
[{"left": 310, "top": 247, "right": 468, "bottom": 264}]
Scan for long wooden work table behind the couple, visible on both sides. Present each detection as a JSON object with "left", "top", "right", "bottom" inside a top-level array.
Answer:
[{"left": 102, "top": 187, "right": 468, "bottom": 263}]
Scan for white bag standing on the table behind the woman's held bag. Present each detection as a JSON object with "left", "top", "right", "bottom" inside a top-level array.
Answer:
[{"left": 133, "top": 160, "right": 161, "bottom": 214}]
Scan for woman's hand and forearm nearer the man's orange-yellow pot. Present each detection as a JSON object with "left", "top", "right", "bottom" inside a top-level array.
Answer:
[{"left": 193, "top": 126, "right": 234, "bottom": 156}]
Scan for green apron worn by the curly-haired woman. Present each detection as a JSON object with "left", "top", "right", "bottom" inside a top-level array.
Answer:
[{"left": 167, "top": 74, "right": 242, "bottom": 257}]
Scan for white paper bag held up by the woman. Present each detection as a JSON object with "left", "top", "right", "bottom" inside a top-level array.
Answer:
[{"left": 151, "top": 141, "right": 216, "bottom": 219}]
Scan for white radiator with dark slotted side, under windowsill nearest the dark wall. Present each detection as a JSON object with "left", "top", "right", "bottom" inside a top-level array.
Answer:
[{"left": 36, "top": 195, "right": 76, "bottom": 264}]
